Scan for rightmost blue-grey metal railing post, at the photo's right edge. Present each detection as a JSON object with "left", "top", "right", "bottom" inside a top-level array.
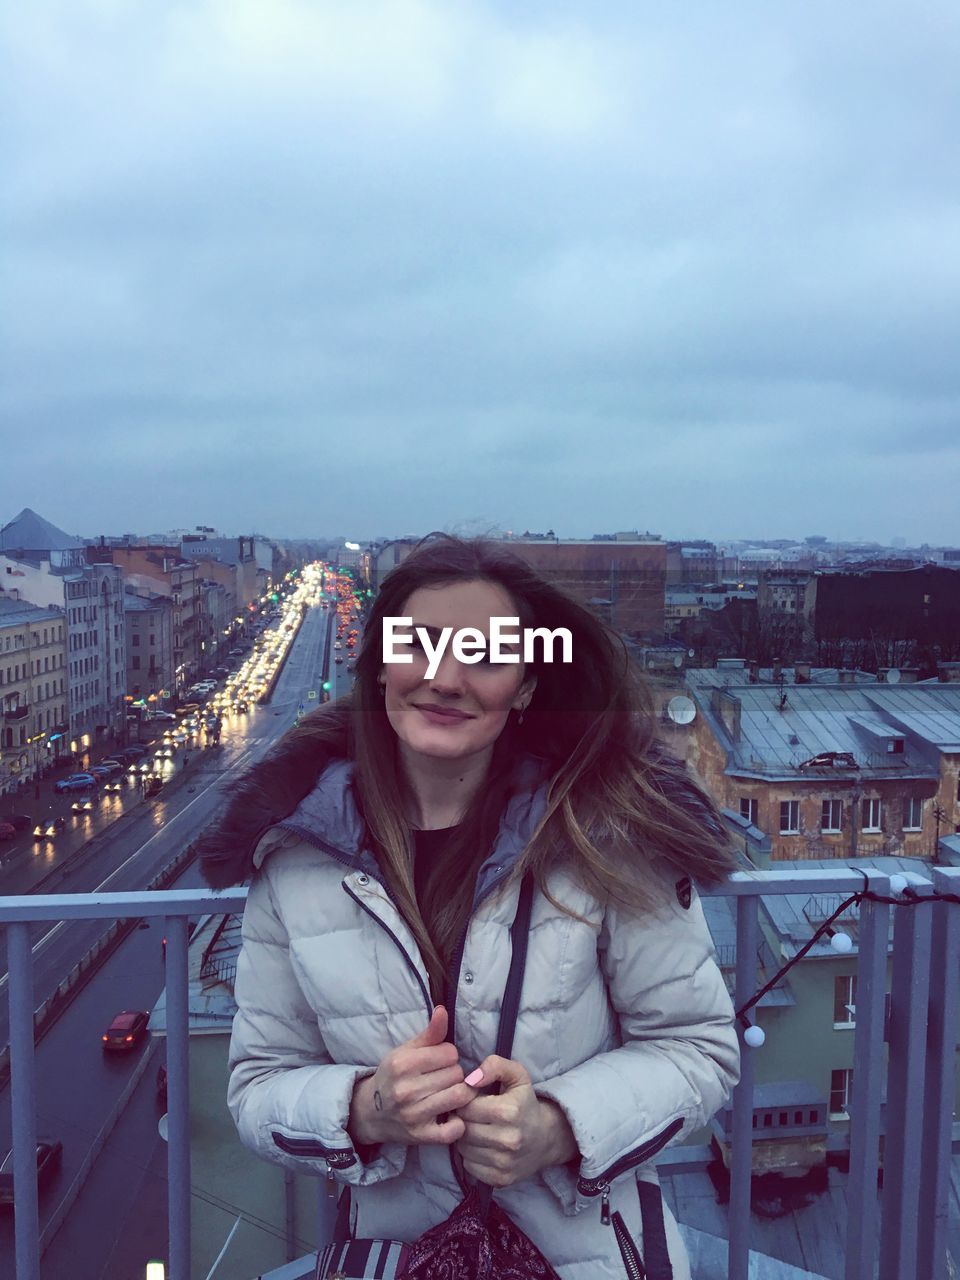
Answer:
[{"left": 916, "top": 868, "right": 960, "bottom": 1280}]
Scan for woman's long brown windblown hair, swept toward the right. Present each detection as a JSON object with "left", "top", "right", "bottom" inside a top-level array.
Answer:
[{"left": 335, "top": 534, "right": 736, "bottom": 1000}]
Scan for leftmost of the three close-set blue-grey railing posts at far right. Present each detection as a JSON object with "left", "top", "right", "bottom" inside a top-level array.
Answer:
[{"left": 844, "top": 872, "right": 890, "bottom": 1280}]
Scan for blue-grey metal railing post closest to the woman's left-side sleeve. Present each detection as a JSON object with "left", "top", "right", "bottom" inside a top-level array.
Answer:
[{"left": 164, "top": 915, "right": 191, "bottom": 1280}]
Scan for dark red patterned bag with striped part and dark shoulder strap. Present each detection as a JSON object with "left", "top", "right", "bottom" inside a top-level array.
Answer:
[{"left": 316, "top": 874, "right": 558, "bottom": 1280}]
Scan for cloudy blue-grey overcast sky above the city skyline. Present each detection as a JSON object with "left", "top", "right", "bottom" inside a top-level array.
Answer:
[{"left": 0, "top": 0, "right": 960, "bottom": 545}]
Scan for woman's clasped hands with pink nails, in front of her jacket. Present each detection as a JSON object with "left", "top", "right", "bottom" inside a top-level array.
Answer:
[{"left": 349, "top": 1005, "right": 577, "bottom": 1187}]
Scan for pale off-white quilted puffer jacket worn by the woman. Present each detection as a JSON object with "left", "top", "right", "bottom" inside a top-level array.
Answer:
[{"left": 228, "top": 760, "right": 739, "bottom": 1280}]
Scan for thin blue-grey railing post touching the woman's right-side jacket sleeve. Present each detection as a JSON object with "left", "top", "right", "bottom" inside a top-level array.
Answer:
[{"left": 727, "top": 893, "right": 759, "bottom": 1280}]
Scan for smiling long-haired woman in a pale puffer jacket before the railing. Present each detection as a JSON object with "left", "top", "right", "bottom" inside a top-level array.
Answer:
[{"left": 202, "top": 535, "right": 739, "bottom": 1280}]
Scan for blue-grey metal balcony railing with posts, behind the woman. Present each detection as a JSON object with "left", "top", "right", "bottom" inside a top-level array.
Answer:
[{"left": 0, "top": 865, "right": 960, "bottom": 1280}]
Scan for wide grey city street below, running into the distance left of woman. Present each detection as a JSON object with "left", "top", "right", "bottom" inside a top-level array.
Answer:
[{"left": 0, "top": 608, "right": 348, "bottom": 1280}]
